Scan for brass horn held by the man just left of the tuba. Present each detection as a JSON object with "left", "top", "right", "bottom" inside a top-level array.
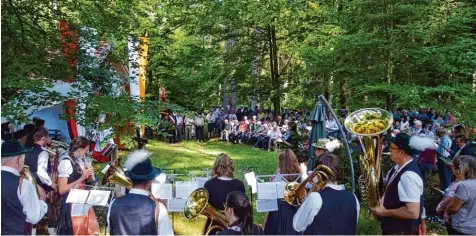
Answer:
[{"left": 284, "top": 165, "right": 334, "bottom": 206}]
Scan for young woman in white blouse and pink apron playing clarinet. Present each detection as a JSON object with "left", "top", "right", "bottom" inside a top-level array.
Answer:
[{"left": 57, "top": 136, "right": 99, "bottom": 235}]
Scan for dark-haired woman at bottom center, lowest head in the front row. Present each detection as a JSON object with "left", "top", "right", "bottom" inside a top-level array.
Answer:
[{"left": 218, "top": 191, "right": 264, "bottom": 235}]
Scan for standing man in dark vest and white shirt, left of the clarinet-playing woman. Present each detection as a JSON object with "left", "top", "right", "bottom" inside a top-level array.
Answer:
[{"left": 25, "top": 127, "right": 57, "bottom": 234}]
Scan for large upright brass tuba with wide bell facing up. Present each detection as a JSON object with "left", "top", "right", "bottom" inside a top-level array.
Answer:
[{"left": 344, "top": 108, "right": 393, "bottom": 207}]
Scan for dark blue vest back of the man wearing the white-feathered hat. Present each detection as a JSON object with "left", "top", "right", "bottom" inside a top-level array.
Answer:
[{"left": 109, "top": 193, "right": 157, "bottom": 235}]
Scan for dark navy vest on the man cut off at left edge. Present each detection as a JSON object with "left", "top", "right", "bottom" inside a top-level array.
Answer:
[{"left": 2, "top": 170, "right": 26, "bottom": 235}]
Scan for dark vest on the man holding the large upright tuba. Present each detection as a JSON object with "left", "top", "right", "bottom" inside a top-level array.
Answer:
[{"left": 380, "top": 160, "right": 423, "bottom": 234}]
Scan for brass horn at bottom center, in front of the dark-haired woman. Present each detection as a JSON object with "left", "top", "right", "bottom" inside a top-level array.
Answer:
[{"left": 184, "top": 188, "right": 228, "bottom": 235}]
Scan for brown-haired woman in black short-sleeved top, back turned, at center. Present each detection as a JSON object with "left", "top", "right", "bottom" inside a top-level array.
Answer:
[{"left": 203, "top": 153, "right": 245, "bottom": 234}]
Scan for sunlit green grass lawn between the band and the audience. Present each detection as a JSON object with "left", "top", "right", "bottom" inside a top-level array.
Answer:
[{"left": 114, "top": 141, "right": 446, "bottom": 235}]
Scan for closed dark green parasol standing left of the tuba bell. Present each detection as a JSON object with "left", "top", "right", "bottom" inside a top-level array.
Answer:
[{"left": 307, "top": 101, "right": 327, "bottom": 170}]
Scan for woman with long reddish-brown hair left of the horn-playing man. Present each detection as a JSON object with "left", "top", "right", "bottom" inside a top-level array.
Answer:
[{"left": 264, "top": 149, "right": 307, "bottom": 235}]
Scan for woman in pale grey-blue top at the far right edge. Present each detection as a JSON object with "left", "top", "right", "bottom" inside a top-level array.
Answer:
[{"left": 445, "top": 156, "right": 476, "bottom": 235}]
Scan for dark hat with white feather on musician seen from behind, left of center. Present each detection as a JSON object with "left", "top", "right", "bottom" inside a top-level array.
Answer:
[{"left": 126, "top": 149, "right": 161, "bottom": 180}]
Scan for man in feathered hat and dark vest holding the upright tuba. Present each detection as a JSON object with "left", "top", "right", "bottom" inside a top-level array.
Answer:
[{"left": 370, "top": 133, "right": 423, "bottom": 235}]
